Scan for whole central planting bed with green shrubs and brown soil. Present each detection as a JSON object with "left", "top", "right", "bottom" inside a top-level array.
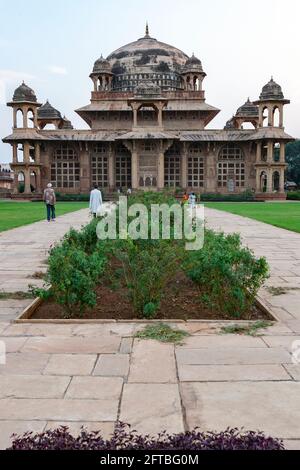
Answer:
[{"left": 17, "top": 193, "right": 274, "bottom": 322}]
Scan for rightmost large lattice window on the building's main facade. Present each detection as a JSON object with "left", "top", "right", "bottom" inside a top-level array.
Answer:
[{"left": 218, "top": 144, "right": 245, "bottom": 192}]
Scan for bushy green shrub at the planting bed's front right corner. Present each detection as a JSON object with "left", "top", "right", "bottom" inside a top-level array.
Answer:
[{"left": 183, "top": 230, "right": 268, "bottom": 318}]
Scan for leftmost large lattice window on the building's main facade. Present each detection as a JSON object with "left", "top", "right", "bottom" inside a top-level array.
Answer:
[{"left": 51, "top": 145, "right": 80, "bottom": 189}]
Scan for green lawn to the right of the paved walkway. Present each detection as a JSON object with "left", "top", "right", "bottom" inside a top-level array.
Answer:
[{"left": 205, "top": 202, "right": 300, "bottom": 233}]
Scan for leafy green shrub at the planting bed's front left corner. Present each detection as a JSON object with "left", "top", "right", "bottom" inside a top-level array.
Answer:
[{"left": 38, "top": 243, "right": 106, "bottom": 318}]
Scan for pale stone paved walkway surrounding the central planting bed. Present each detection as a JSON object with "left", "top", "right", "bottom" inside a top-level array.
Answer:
[{"left": 0, "top": 206, "right": 300, "bottom": 448}]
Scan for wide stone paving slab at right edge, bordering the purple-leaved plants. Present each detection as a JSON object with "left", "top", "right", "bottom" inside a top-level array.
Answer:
[{"left": 181, "top": 382, "right": 300, "bottom": 439}]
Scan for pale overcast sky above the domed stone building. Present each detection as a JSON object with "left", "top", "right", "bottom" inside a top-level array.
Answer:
[{"left": 0, "top": 0, "right": 300, "bottom": 162}]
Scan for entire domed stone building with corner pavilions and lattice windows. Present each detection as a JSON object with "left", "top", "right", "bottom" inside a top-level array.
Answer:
[{"left": 3, "top": 26, "right": 293, "bottom": 199}]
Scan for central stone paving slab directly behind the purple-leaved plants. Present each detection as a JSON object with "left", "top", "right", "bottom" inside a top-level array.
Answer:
[{"left": 120, "top": 384, "right": 184, "bottom": 435}]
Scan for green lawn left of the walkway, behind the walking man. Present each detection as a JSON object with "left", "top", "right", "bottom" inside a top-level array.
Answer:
[{"left": 0, "top": 201, "right": 88, "bottom": 232}]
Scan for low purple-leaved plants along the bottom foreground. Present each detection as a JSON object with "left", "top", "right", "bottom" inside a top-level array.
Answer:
[{"left": 8, "top": 423, "right": 284, "bottom": 451}]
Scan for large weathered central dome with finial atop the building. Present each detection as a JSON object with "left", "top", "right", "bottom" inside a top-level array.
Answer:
[{"left": 102, "top": 28, "right": 189, "bottom": 91}]
